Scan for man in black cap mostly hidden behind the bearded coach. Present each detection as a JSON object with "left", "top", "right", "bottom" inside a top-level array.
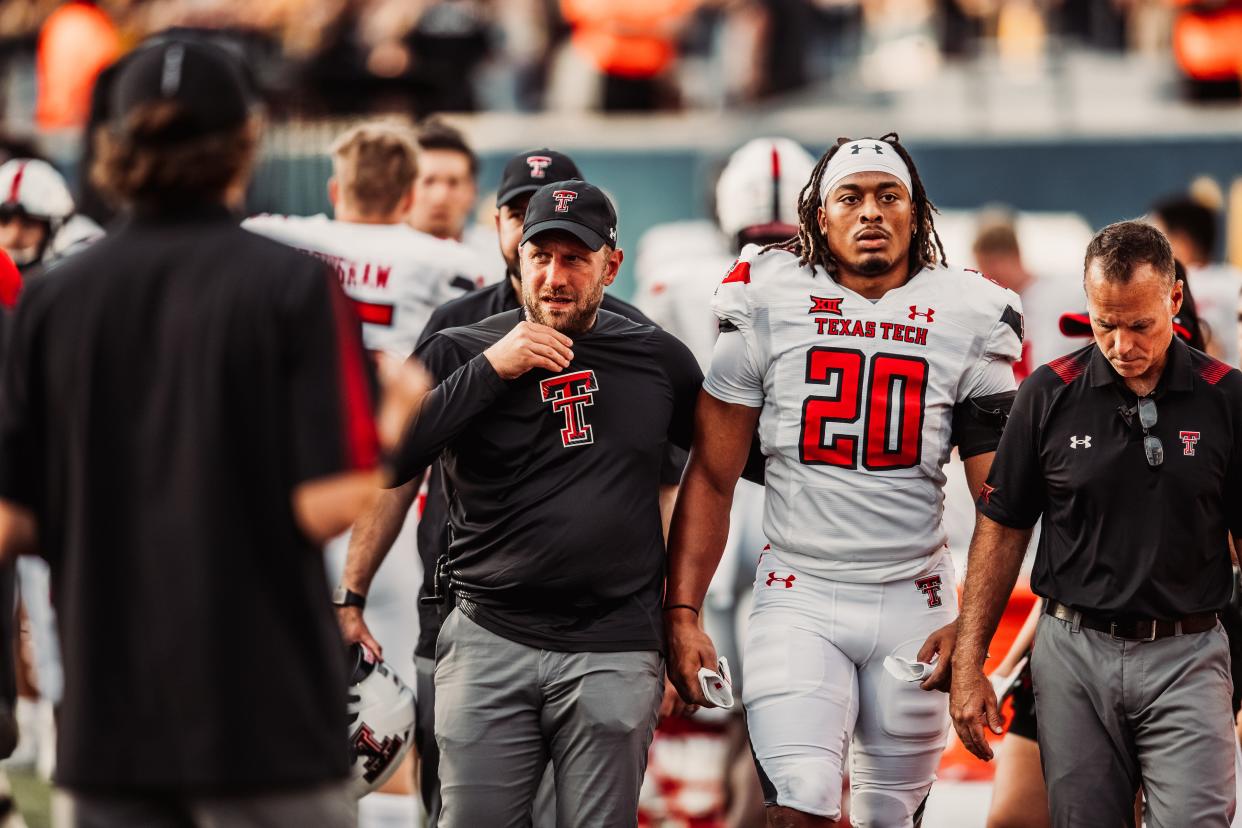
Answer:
[{"left": 339, "top": 148, "right": 670, "bottom": 828}]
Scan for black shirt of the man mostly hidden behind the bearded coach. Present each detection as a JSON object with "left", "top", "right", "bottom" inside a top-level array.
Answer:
[{"left": 414, "top": 278, "right": 686, "bottom": 658}]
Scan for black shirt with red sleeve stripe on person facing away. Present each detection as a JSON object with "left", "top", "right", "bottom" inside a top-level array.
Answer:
[{"left": 0, "top": 207, "right": 378, "bottom": 792}]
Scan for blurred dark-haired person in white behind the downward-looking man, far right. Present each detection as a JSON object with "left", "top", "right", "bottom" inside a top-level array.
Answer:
[{"left": 1151, "top": 196, "right": 1242, "bottom": 367}]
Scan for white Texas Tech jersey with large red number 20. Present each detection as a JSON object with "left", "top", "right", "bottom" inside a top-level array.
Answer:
[{"left": 704, "top": 246, "right": 1022, "bottom": 582}]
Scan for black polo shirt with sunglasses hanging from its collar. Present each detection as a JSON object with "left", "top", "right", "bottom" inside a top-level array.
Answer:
[{"left": 979, "top": 338, "right": 1242, "bottom": 618}]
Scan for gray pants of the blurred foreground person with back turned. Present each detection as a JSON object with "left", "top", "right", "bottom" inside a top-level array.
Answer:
[{"left": 52, "top": 783, "right": 358, "bottom": 828}]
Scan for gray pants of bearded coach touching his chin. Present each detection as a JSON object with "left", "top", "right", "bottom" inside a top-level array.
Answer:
[{"left": 436, "top": 610, "right": 664, "bottom": 828}]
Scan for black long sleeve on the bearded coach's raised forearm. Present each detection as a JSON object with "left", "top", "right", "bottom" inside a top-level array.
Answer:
[{"left": 392, "top": 336, "right": 508, "bottom": 485}]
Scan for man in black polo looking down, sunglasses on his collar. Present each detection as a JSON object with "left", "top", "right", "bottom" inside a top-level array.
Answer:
[{"left": 950, "top": 222, "right": 1242, "bottom": 828}]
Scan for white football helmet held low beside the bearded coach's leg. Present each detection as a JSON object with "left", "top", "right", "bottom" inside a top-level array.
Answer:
[{"left": 347, "top": 644, "right": 414, "bottom": 798}]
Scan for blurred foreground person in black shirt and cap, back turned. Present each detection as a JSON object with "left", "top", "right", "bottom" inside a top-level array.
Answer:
[{"left": 0, "top": 41, "right": 426, "bottom": 828}]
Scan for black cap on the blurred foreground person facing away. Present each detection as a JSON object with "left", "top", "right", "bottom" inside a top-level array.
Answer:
[{"left": 109, "top": 38, "right": 250, "bottom": 140}]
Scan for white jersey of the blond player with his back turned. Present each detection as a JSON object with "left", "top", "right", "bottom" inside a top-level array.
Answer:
[{"left": 242, "top": 214, "right": 483, "bottom": 358}]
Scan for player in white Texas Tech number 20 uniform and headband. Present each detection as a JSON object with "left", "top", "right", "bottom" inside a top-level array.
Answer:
[{"left": 664, "top": 134, "right": 1022, "bottom": 828}]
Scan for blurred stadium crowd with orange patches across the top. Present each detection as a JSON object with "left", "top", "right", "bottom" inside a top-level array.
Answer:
[{"left": 0, "top": 0, "right": 1242, "bottom": 129}]
